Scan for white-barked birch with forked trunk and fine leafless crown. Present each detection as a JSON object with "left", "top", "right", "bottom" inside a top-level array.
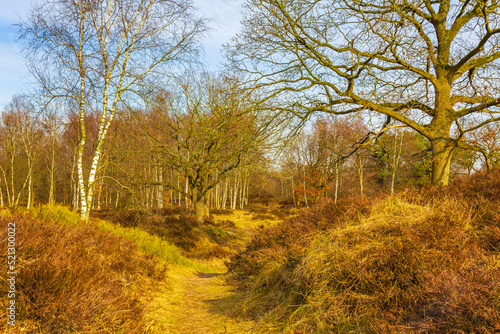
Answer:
[{"left": 18, "top": 0, "right": 206, "bottom": 220}]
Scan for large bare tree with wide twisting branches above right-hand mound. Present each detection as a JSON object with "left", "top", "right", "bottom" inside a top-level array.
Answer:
[{"left": 227, "top": 0, "right": 500, "bottom": 185}]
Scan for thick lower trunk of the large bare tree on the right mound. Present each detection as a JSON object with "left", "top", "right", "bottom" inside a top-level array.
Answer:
[{"left": 431, "top": 138, "right": 455, "bottom": 186}]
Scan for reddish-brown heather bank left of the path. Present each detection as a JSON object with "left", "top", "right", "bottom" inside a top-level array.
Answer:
[{"left": 0, "top": 210, "right": 166, "bottom": 333}]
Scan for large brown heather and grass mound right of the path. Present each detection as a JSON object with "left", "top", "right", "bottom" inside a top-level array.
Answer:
[{"left": 231, "top": 171, "right": 500, "bottom": 333}]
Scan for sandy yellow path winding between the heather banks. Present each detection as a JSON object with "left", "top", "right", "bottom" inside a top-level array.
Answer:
[{"left": 144, "top": 214, "right": 268, "bottom": 334}]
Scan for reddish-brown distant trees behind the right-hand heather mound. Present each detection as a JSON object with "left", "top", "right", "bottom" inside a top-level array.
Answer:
[{"left": 251, "top": 116, "right": 500, "bottom": 205}]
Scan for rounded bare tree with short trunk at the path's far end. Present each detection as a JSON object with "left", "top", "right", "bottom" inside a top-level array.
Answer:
[{"left": 137, "top": 75, "right": 273, "bottom": 220}]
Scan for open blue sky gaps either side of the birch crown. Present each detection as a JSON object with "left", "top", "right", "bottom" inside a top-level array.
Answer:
[{"left": 0, "top": 0, "right": 243, "bottom": 109}]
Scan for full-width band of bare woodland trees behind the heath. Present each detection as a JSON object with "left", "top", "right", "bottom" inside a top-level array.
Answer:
[{"left": 0, "top": 92, "right": 499, "bottom": 213}]
